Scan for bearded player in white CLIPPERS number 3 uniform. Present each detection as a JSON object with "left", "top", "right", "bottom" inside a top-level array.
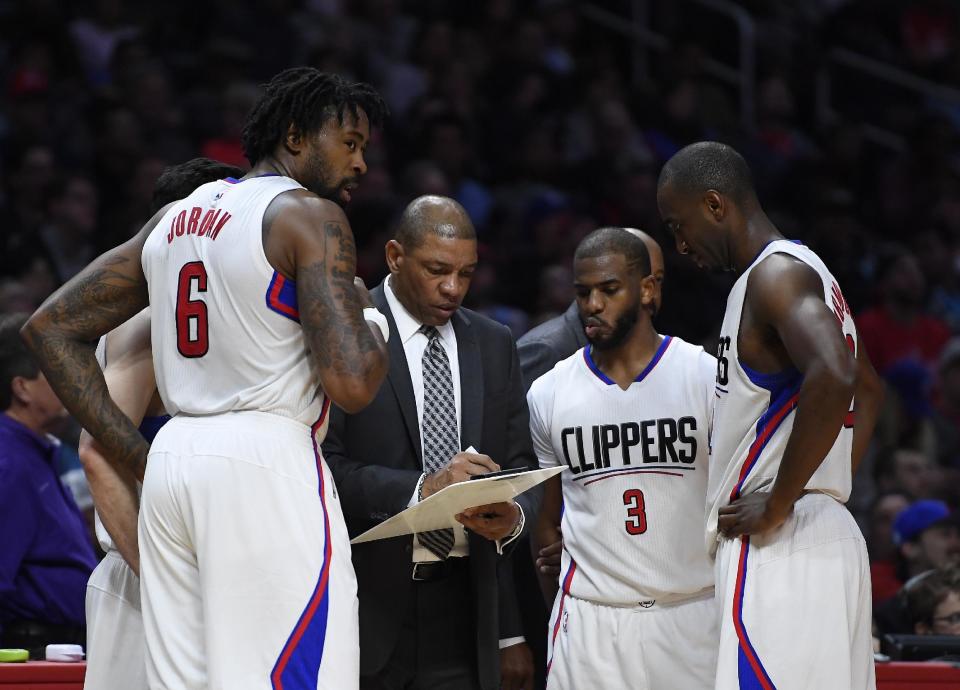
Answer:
[{"left": 527, "top": 228, "right": 717, "bottom": 690}]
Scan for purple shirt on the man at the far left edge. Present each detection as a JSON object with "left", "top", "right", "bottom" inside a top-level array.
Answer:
[{"left": 0, "top": 413, "right": 97, "bottom": 629}]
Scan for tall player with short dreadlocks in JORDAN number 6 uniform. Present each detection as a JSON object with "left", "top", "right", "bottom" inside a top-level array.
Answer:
[{"left": 24, "top": 68, "right": 387, "bottom": 690}]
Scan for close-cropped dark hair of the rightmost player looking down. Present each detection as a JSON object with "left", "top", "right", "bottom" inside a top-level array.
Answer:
[{"left": 657, "top": 141, "right": 757, "bottom": 206}]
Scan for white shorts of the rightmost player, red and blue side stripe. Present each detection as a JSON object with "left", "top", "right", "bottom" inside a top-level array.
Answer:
[{"left": 716, "top": 494, "right": 876, "bottom": 690}]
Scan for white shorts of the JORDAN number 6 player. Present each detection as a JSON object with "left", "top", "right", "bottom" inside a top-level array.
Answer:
[{"left": 139, "top": 412, "right": 360, "bottom": 690}]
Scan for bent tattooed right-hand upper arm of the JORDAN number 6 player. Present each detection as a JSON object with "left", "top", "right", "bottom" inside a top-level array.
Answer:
[{"left": 263, "top": 191, "right": 388, "bottom": 413}]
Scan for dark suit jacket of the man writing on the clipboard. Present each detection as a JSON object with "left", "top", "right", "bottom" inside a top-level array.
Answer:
[{"left": 323, "top": 284, "right": 540, "bottom": 690}]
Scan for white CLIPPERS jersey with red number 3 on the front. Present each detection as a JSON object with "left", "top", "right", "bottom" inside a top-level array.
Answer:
[{"left": 527, "top": 336, "right": 716, "bottom": 606}]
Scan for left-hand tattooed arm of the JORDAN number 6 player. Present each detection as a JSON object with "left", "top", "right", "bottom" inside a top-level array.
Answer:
[{"left": 21, "top": 209, "right": 166, "bottom": 479}]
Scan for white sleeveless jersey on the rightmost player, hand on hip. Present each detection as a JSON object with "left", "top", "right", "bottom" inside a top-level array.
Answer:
[{"left": 707, "top": 240, "right": 857, "bottom": 551}]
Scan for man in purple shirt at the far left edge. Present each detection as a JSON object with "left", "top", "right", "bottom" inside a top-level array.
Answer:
[{"left": 0, "top": 314, "right": 97, "bottom": 655}]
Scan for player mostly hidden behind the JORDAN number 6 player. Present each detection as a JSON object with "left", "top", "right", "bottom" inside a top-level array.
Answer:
[{"left": 80, "top": 158, "right": 243, "bottom": 690}]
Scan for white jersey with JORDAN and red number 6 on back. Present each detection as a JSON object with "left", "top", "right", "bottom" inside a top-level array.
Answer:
[{"left": 142, "top": 175, "right": 325, "bottom": 432}]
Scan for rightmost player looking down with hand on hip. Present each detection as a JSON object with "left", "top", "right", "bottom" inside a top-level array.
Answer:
[{"left": 657, "top": 142, "right": 882, "bottom": 690}]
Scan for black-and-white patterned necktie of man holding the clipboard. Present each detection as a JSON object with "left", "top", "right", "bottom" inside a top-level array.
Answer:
[{"left": 417, "top": 326, "right": 460, "bottom": 560}]
